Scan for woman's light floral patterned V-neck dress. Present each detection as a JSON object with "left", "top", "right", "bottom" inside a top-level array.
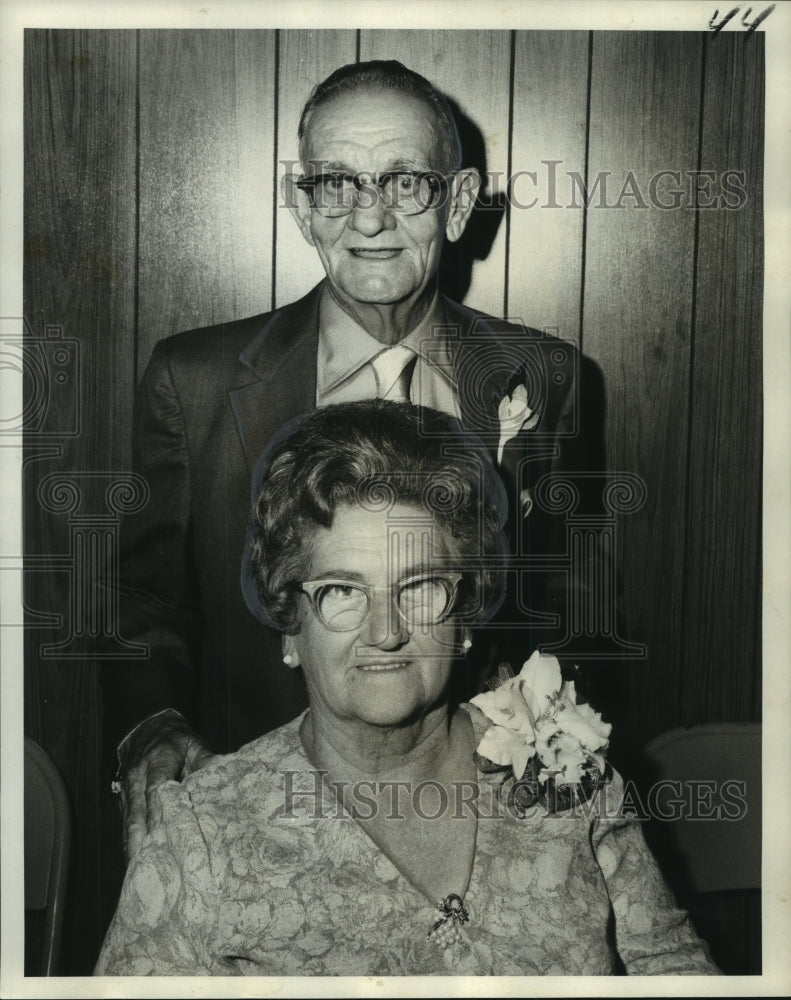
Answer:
[{"left": 95, "top": 706, "right": 717, "bottom": 976}]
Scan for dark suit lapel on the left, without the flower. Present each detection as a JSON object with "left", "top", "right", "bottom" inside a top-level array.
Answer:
[{"left": 228, "top": 285, "right": 321, "bottom": 473}]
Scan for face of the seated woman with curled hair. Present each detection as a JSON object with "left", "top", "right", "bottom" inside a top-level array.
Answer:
[{"left": 285, "top": 504, "right": 462, "bottom": 726}]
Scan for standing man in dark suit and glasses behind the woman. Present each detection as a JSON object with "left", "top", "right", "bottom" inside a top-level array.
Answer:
[{"left": 104, "top": 62, "right": 596, "bottom": 851}]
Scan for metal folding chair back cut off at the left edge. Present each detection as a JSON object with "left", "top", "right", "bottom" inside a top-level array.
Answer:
[{"left": 24, "top": 736, "right": 71, "bottom": 976}]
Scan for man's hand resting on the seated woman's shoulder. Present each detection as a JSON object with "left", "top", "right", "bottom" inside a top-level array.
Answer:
[{"left": 113, "top": 709, "right": 214, "bottom": 864}]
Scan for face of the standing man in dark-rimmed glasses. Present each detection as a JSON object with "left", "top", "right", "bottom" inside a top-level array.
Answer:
[{"left": 295, "top": 91, "right": 471, "bottom": 312}]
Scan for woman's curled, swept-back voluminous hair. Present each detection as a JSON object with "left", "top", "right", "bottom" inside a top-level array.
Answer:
[{"left": 242, "top": 400, "right": 509, "bottom": 634}]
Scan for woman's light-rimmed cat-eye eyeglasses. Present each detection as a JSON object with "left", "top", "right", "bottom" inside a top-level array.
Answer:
[{"left": 300, "top": 573, "right": 462, "bottom": 632}]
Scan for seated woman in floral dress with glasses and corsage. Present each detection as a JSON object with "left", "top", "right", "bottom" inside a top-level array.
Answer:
[{"left": 96, "top": 402, "right": 716, "bottom": 976}]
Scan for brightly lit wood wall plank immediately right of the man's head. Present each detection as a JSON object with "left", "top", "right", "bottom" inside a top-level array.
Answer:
[{"left": 360, "top": 31, "right": 511, "bottom": 316}]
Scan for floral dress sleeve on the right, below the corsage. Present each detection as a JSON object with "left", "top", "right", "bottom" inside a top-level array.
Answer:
[{"left": 592, "top": 773, "right": 719, "bottom": 976}]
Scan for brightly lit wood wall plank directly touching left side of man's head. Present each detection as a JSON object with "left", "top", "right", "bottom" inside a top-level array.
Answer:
[{"left": 275, "top": 31, "right": 357, "bottom": 306}]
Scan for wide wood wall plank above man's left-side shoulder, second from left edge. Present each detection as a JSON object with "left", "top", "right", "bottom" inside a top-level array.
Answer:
[{"left": 138, "top": 30, "right": 275, "bottom": 375}]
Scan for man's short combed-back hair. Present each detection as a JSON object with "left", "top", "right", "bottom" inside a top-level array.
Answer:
[{"left": 297, "top": 59, "right": 461, "bottom": 171}]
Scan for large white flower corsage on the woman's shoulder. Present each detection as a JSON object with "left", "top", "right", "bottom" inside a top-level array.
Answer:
[{"left": 472, "top": 651, "right": 612, "bottom": 805}]
